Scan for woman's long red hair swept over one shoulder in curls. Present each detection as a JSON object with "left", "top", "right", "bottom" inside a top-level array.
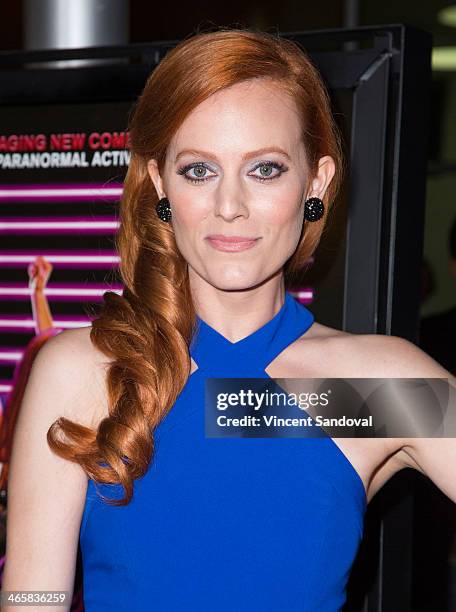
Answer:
[{"left": 48, "top": 28, "right": 343, "bottom": 505}]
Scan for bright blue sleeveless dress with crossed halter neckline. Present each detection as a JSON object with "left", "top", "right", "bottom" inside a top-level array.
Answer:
[{"left": 80, "top": 293, "right": 367, "bottom": 612}]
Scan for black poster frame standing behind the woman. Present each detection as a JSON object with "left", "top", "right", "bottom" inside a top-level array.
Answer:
[{"left": 0, "top": 24, "right": 432, "bottom": 612}]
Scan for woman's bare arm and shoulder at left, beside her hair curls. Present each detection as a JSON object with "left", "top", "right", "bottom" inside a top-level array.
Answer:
[{"left": 2, "top": 330, "right": 88, "bottom": 612}]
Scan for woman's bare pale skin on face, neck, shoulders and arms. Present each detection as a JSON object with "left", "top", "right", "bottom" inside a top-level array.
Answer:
[{"left": 3, "top": 75, "right": 456, "bottom": 612}]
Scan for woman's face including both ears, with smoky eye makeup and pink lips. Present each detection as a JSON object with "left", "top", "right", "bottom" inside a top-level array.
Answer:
[{"left": 149, "top": 79, "right": 334, "bottom": 290}]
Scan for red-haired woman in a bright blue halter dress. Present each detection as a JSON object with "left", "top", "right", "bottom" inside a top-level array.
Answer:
[{"left": 4, "top": 29, "right": 456, "bottom": 612}]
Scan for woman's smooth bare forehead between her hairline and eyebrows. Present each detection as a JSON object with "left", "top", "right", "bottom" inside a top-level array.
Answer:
[{"left": 170, "top": 79, "right": 301, "bottom": 155}]
